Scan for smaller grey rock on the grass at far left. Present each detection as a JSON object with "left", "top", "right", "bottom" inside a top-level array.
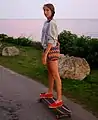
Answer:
[{"left": 2, "top": 46, "right": 19, "bottom": 56}]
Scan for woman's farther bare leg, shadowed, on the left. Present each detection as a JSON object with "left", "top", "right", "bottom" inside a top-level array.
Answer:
[{"left": 47, "top": 63, "right": 54, "bottom": 93}]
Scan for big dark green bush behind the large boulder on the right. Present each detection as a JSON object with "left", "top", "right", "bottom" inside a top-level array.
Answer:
[{"left": 58, "top": 30, "right": 98, "bottom": 67}]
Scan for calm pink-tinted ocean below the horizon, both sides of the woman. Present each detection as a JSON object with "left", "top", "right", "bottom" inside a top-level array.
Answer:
[{"left": 0, "top": 19, "right": 98, "bottom": 41}]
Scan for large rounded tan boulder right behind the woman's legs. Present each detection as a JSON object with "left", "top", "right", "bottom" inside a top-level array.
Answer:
[{"left": 59, "top": 55, "right": 90, "bottom": 80}]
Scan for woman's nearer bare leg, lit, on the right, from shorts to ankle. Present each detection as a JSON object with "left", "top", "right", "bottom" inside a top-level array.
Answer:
[{"left": 48, "top": 60, "right": 62, "bottom": 101}]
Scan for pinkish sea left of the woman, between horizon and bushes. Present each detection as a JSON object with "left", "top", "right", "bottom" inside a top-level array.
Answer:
[{"left": 0, "top": 20, "right": 43, "bottom": 39}]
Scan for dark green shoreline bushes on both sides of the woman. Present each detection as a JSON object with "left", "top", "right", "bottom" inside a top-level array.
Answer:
[{"left": 0, "top": 30, "right": 98, "bottom": 67}]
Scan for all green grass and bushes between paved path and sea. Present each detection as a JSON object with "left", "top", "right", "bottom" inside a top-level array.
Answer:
[{"left": 0, "top": 31, "right": 98, "bottom": 116}]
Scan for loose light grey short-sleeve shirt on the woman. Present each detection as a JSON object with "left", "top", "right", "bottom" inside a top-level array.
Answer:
[{"left": 41, "top": 19, "right": 58, "bottom": 49}]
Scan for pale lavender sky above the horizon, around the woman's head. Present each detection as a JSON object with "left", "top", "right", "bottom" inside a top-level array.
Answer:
[{"left": 0, "top": 0, "right": 98, "bottom": 19}]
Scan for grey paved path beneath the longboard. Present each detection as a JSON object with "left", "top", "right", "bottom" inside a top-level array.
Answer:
[{"left": 0, "top": 66, "right": 98, "bottom": 120}]
